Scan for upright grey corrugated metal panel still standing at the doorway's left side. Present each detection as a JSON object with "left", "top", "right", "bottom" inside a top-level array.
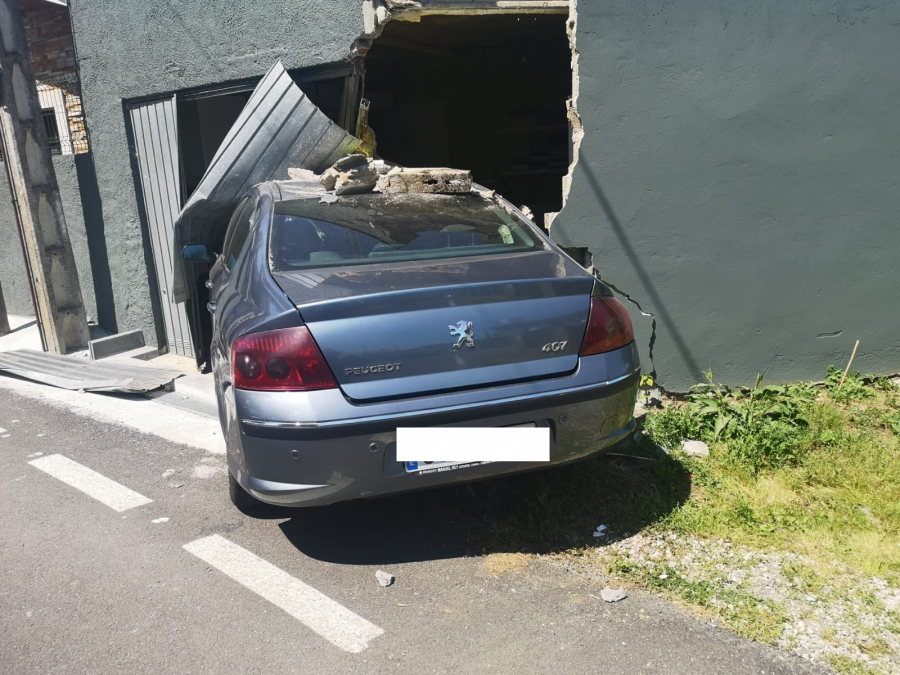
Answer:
[{"left": 130, "top": 97, "right": 194, "bottom": 356}]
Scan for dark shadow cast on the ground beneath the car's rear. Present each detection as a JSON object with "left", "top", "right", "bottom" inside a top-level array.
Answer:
[{"left": 278, "top": 448, "right": 691, "bottom": 565}]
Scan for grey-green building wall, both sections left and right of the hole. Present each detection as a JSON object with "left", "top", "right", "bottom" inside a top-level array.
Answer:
[{"left": 56, "top": 0, "right": 900, "bottom": 390}]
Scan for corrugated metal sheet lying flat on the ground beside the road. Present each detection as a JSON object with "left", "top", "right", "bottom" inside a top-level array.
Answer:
[{"left": 0, "top": 349, "right": 183, "bottom": 394}]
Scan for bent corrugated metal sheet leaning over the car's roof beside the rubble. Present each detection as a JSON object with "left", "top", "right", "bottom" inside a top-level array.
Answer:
[{"left": 173, "top": 62, "right": 360, "bottom": 302}]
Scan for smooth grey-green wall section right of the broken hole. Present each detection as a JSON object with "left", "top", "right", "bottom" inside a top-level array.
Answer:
[{"left": 552, "top": 0, "right": 900, "bottom": 390}]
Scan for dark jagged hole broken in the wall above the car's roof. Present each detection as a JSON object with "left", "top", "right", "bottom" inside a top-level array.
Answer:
[{"left": 365, "top": 14, "right": 572, "bottom": 224}]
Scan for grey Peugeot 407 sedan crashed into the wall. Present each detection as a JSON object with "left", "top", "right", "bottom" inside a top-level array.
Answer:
[{"left": 183, "top": 181, "right": 640, "bottom": 510}]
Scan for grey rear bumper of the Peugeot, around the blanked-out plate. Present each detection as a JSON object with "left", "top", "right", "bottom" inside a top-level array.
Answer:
[{"left": 228, "top": 346, "right": 640, "bottom": 506}]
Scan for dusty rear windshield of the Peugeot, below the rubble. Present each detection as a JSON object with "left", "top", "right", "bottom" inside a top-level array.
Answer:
[{"left": 270, "top": 193, "right": 544, "bottom": 272}]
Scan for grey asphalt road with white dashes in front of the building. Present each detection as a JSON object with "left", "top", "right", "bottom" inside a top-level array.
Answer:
[{"left": 0, "top": 389, "right": 819, "bottom": 675}]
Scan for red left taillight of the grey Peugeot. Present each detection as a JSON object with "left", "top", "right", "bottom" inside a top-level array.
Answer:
[{"left": 231, "top": 326, "right": 337, "bottom": 391}]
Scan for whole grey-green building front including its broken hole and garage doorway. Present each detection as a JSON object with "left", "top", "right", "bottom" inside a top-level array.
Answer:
[{"left": 0, "top": 0, "right": 900, "bottom": 390}]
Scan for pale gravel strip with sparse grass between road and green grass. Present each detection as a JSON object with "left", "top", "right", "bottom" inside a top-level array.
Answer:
[{"left": 564, "top": 533, "right": 900, "bottom": 675}]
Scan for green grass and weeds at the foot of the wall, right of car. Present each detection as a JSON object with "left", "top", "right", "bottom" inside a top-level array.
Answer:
[{"left": 647, "top": 369, "right": 900, "bottom": 585}]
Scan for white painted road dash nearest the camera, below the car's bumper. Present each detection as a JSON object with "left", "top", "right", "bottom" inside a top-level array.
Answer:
[{"left": 184, "top": 534, "right": 384, "bottom": 654}]
